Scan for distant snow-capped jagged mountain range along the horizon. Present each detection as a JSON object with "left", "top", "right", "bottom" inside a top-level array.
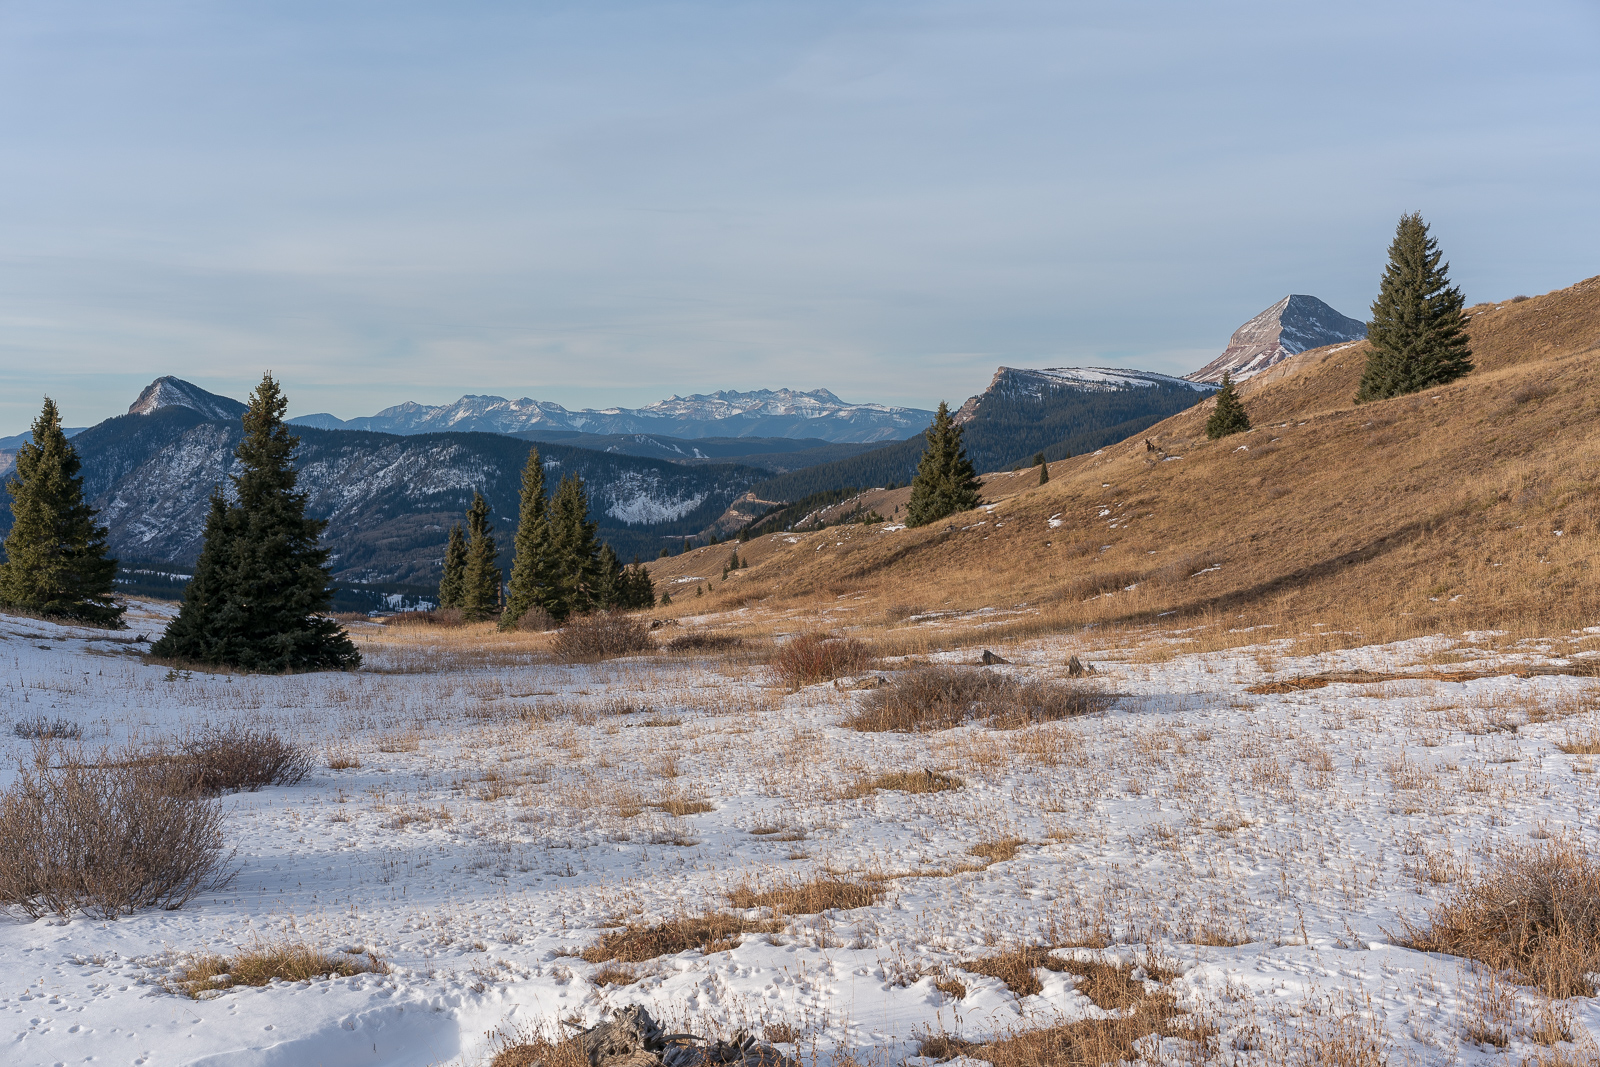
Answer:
[{"left": 290, "top": 389, "right": 933, "bottom": 442}]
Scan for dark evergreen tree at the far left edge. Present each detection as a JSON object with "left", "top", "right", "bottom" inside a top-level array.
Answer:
[{"left": 0, "top": 397, "right": 123, "bottom": 627}]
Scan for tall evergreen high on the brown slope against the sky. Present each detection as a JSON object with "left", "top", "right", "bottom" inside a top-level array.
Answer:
[{"left": 1355, "top": 213, "right": 1472, "bottom": 403}]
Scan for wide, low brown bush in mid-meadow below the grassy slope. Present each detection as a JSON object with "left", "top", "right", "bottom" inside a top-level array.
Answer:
[{"left": 845, "top": 667, "right": 1114, "bottom": 733}]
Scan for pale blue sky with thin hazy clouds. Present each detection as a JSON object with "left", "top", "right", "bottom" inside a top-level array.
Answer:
[{"left": 0, "top": 0, "right": 1600, "bottom": 434}]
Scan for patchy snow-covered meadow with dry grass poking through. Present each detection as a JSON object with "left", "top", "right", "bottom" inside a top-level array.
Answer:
[{"left": 0, "top": 608, "right": 1600, "bottom": 1067}]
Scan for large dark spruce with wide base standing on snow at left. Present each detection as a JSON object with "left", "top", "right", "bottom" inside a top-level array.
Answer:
[{"left": 150, "top": 374, "right": 362, "bottom": 672}]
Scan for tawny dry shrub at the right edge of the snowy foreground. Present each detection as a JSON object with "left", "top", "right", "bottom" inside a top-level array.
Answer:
[{"left": 1398, "top": 840, "right": 1600, "bottom": 1000}]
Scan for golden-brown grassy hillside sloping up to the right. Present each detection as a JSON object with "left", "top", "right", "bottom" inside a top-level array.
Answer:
[{"left": 651, "top": 278, "right": 1600, "bottom": 639}]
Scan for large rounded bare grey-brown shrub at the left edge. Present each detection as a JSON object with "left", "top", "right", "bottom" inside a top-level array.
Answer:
[{"left": 0, "top": 745, "right": 237, "bottom": 918}]
